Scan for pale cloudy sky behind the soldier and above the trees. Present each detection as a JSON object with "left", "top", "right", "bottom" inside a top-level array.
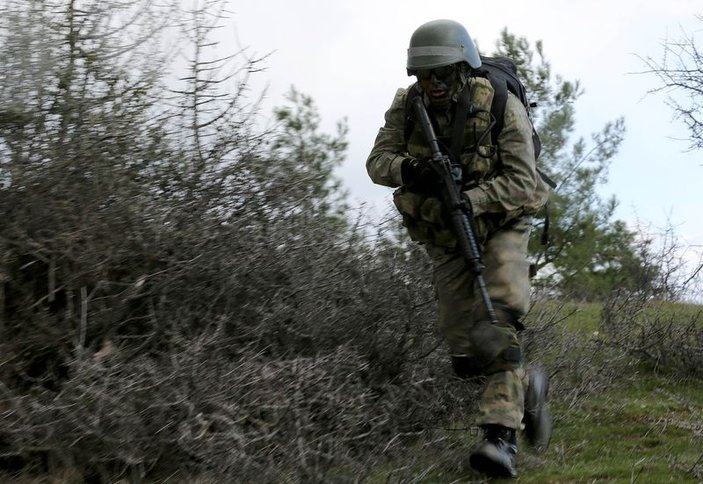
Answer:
[{"left": 228, "top": 0, "right": 703, "bottom": 268}]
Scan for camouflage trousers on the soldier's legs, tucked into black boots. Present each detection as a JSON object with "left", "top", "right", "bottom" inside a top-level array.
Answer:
[{"left": 427, "top": 217, "right": 531, "bottom": 429}]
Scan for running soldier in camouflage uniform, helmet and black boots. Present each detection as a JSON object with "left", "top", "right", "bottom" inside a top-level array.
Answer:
[{"left": 366, "top": 20, "right": 551, "bottom": 477}]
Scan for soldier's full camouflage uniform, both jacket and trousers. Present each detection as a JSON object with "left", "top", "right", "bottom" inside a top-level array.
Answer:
[{"left": 366, "top": 73, "right": 548, "bottom": 429}]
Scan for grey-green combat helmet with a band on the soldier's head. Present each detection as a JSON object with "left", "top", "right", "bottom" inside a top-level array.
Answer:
[{"left": 406, "top": 20, "right": 481, "bottom": 76}]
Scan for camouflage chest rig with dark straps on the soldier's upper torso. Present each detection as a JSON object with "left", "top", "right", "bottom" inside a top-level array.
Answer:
[{"left": 405, "top": 77, "right": 500, "bottom": 188}]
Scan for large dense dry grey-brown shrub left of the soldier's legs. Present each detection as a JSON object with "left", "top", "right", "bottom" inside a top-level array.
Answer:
[{"left": 0, "top": 198, "right": 486, "bottom": 482}]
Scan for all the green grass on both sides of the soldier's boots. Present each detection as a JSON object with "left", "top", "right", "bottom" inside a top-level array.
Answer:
[{"left": 372, "top": 305, "right": 703, "bottom": 483}]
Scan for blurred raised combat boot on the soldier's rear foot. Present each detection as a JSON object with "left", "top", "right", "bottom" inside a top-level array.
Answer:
[{"left": 522, "top": 368, "right": 552, "bottom": 452}]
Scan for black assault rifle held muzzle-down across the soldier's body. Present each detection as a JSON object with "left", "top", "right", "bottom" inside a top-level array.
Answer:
[{"left": 413, "top": 96, "right": 498, "bottom": 323}]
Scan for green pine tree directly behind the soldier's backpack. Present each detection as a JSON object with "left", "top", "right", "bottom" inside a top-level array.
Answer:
[{"left": 495, "top": 31, "right": 652, "bottom": 299}]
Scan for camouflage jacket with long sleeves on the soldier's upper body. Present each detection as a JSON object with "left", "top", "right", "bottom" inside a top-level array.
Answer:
[{"left": 366, "top": 78, "right": 548, "bottom": 244}]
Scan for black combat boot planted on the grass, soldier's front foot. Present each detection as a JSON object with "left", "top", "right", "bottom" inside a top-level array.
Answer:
[{"left": 469, "top": 425, "right": 517, "bottom": 478}]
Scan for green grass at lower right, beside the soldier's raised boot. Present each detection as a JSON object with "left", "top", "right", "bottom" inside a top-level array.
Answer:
[{"left": 520, "top": 375, "right": 703, "bottom": 483}]
